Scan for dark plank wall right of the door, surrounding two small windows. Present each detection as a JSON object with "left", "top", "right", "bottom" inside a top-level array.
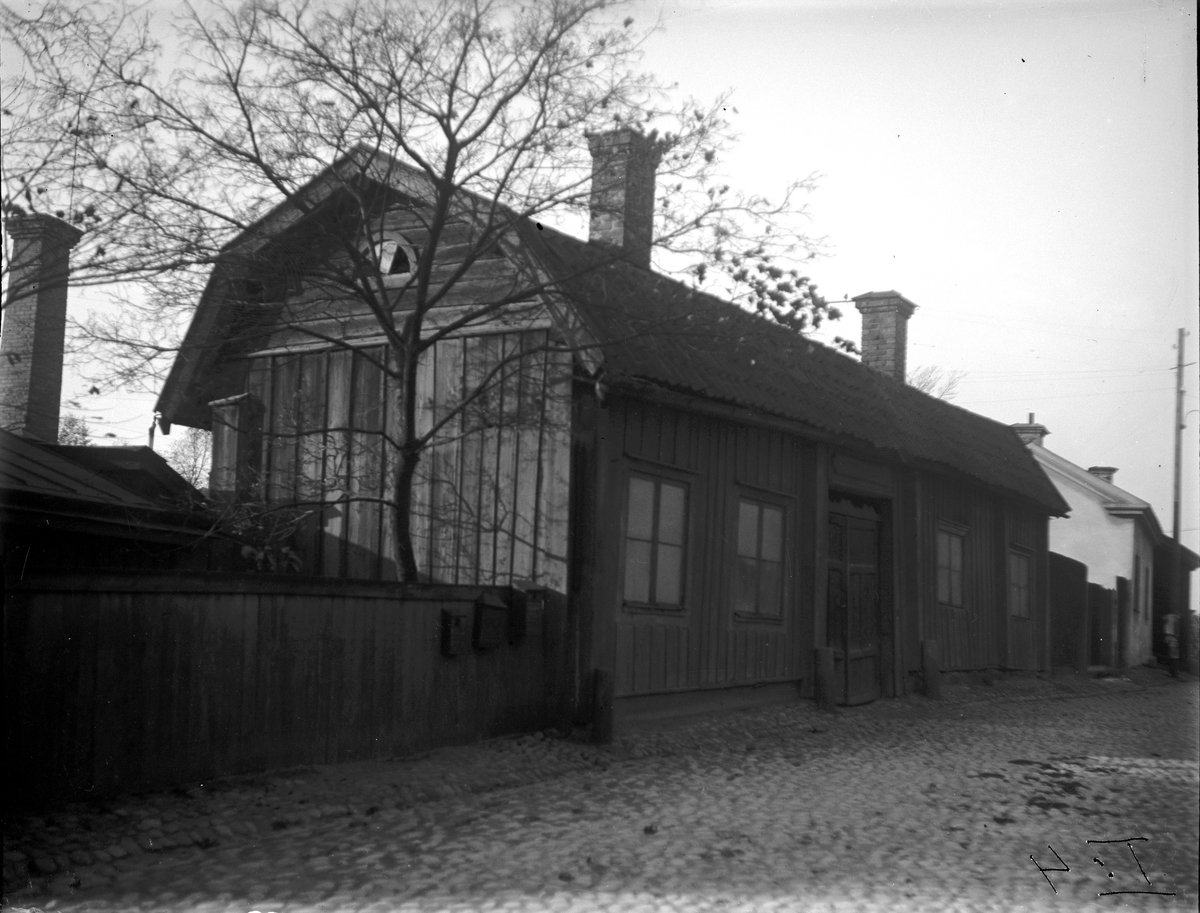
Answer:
[{"left": 910, "top": 473, "right": 1048, "bottom": 672}]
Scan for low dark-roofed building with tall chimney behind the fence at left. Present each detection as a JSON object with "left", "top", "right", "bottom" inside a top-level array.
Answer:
[{"left": 0, "top": 215, "right": 211, "bottom": 579}]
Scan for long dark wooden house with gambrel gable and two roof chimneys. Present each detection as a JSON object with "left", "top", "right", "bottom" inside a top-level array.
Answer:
[{"left": 158, "top": 131, "right": 1067, "bottom": 717}]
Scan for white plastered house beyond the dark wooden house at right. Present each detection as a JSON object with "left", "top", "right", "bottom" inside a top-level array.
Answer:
[{"left": 1013, "top": 414, "right": 1165, "bottom": 667}]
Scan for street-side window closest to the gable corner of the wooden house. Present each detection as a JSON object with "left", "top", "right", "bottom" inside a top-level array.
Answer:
[{"left": 625, "top": 475, "right": 688, "bottom": 607}]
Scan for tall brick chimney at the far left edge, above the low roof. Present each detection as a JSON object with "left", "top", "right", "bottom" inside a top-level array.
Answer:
[{"left": 0, "top": 214, "right": 83, "bottom": 444}]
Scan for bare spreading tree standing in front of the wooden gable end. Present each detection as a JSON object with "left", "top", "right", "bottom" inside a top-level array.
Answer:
[{"left": 4, "top": 0, "right": 836, "bottom": 581}]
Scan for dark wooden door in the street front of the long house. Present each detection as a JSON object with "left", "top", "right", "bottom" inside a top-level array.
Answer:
[{"left": 826, "top": 501, "right": 880, "bottom": 704}]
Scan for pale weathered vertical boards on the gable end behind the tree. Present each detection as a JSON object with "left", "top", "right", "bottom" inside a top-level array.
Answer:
[{"left": 238, "top": 330, "right": 571, "bottom": 583}]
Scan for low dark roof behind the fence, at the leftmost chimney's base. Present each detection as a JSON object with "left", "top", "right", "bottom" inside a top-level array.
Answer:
[{"left": 0, "top": 430, "right": 206, "bottom": 537}]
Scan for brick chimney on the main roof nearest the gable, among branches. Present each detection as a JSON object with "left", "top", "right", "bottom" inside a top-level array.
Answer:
[{"left": 588, "top": 127, "right": 662, "bottom": 269}]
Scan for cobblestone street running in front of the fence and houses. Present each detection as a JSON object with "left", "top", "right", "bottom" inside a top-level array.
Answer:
[{"left": 4, "top": 669, "right": 1200, "bottom": 913}]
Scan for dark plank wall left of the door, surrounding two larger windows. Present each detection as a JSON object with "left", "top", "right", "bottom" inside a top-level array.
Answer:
[{"left": 609, "top": 400, "right": 815, "bottom": 697}]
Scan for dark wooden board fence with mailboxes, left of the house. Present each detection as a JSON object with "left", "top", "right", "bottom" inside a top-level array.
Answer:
[{"left": 4, "top": 572, "right": 572, "bottom": 810}]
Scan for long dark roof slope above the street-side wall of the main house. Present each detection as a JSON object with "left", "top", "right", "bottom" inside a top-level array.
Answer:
[{"left": 522, "top": 227, "right": 1067, "bottom": 513}]
